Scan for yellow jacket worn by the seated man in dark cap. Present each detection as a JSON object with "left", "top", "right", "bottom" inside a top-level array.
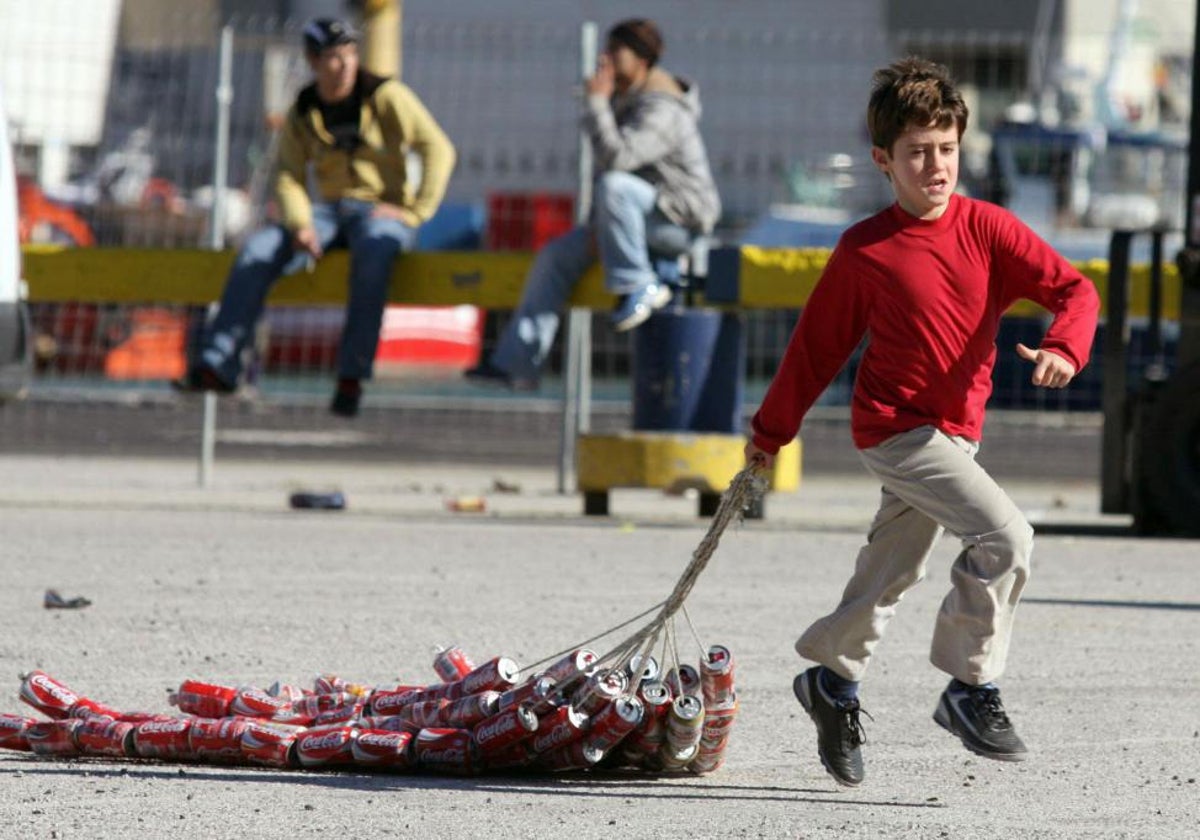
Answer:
[{"left": 275, "top": 71, "right": 455, "bottom": 232}]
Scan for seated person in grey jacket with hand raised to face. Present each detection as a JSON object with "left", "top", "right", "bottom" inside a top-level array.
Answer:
[{"left": 466, "top": 19, "right": 721, "bottom": 390}]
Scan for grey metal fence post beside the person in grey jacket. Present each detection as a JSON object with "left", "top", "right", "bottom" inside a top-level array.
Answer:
[{"left": 558, "top": 20, "right": 596, "bottom": 493}]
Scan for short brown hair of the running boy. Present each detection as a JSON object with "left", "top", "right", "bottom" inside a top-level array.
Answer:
[{"left": 866, "top": 55, "right": 968, "bottom": 155}]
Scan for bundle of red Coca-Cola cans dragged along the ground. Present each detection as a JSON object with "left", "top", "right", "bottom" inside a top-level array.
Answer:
[{"left": 0, "top": 646, "right": 738, "bottom": 775}]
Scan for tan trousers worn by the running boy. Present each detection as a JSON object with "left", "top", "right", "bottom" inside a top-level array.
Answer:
[{"left": 796, "top": 426, "right": 1033, "bottom": 685}]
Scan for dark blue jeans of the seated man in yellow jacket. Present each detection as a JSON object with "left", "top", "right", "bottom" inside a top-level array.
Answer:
[{"left": 200, "top": 198, "right": 416, "bottom": 385}]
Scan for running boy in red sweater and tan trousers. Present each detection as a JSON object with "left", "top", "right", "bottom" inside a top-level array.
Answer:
[{"left": 746, "top": 58, "right": 1099, "bottom": 786}]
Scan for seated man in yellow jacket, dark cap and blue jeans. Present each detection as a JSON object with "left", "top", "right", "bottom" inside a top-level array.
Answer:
[{"left": 180, "top": 18, "right": 455, "bottom": 416}]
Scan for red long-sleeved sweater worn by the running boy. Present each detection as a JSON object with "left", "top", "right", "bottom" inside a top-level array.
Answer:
[{"left": 752, "top": 196, "right": 1099, "bottom": 452}]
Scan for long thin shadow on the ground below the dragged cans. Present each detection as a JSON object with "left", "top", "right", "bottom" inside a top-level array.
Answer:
[{"left": 0, "top": 757, "right": 944, "bottom": 809}]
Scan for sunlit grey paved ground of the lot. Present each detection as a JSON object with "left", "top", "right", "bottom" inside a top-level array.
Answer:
[{"left": 0, "top": 455, "right": 1200, "bottom": 839}]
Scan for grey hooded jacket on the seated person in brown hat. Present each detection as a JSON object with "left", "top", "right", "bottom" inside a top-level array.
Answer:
[{"left": 583, "top": 67, "right": 721, "bottom": 233}]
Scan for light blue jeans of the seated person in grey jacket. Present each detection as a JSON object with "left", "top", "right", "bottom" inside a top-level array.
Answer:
[{"left": 492, "top": 172, "right": 690, "bottom": 380}]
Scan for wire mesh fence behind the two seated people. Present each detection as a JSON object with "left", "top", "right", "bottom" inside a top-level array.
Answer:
[{"left": 0, "top": 0, "right": 1189, "bottom": 475}]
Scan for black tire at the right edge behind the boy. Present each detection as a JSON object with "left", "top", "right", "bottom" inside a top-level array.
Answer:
[{"left": 1140, "top": 364, "right": 1200, "bottom": 536}]
